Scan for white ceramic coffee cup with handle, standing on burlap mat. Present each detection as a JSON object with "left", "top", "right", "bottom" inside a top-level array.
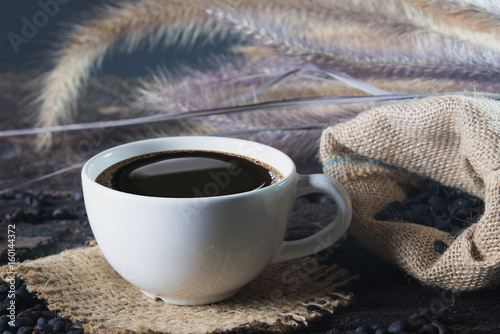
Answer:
[{"left": 82, "top": 136, "right": 352, "bottom": 305}]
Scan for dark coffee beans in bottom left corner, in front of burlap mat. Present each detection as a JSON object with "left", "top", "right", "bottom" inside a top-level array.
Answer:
[{"left": 0, "top": 279, "right": 84, "bottom": 334}]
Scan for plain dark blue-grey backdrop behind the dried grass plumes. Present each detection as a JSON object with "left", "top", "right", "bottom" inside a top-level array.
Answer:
[{"left": 0, "top": 0, "right": 234, "bottom": 76}]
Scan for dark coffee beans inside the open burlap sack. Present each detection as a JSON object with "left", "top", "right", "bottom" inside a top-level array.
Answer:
[{"left": 375, "top": 181, "right": 484, "bottom": 253}]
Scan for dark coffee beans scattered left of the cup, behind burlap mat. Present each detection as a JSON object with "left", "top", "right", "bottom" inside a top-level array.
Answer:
[{"left": 0, "top": 190, "right": 94, "bottom": 264}]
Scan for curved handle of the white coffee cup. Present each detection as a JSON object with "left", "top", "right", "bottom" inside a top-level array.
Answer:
[{"left": 272, "top": 174, "right": 352, "bottom": 263}]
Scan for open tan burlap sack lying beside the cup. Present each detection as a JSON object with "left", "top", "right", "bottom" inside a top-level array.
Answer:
[{"left": 320, "top": 95, "right": 500, "bottom": 290}]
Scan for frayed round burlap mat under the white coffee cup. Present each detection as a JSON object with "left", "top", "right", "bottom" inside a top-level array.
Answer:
[{"left": 0, "top": 246, "right": 353, "bottom": 333}]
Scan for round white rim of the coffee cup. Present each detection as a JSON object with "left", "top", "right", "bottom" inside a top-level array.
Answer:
[{"left": 81, "top": 135, "right": 297, "bottom": 201}]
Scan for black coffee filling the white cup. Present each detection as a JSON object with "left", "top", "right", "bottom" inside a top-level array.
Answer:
[{"left": 96, "top": 150, "right": 283, "bottom": 198}]
